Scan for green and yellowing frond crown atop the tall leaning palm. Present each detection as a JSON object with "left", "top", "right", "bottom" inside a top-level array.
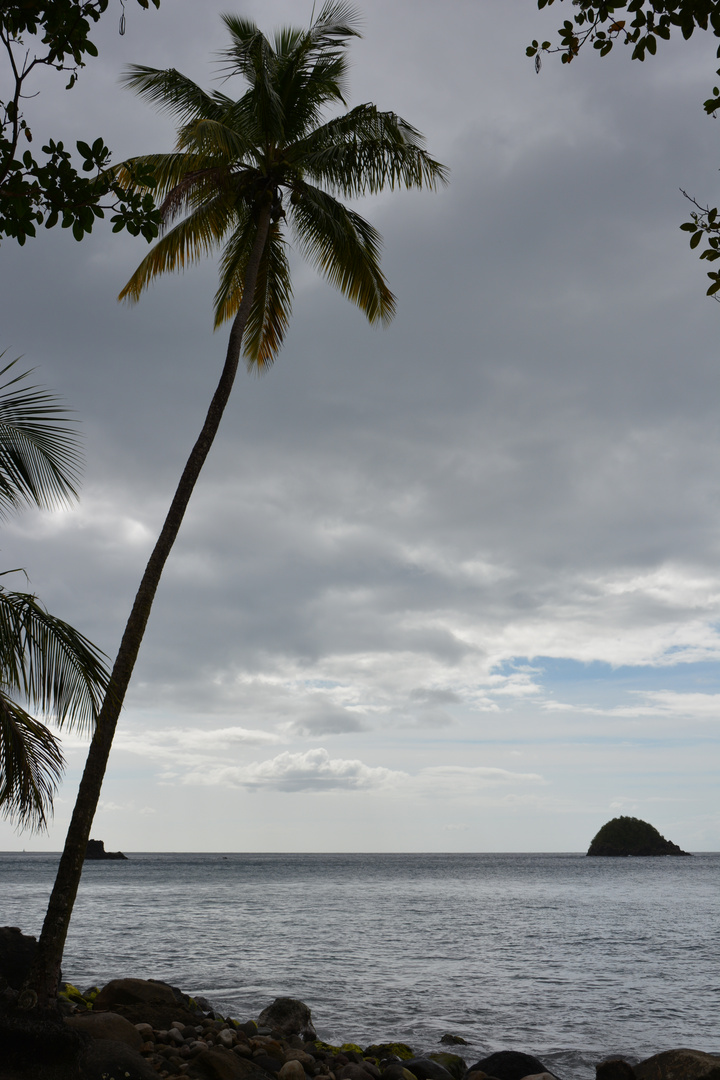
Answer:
[{"left": 119, "top": 3, "right": 446, "bottom": 369}]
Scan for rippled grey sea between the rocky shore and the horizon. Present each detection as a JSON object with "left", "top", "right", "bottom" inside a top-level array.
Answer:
[{"left": 0, "top": 852, "right": 720, "bottom": 1080}]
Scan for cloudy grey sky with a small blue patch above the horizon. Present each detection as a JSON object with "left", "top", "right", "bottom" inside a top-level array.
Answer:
[{"left": 0, "top": 0, "right": 720, "bottom": 852}]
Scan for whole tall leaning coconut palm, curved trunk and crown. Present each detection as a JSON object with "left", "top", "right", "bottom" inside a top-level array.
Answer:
[{"left": 28, "top": 2, "right": 446, "bottom": 1003}]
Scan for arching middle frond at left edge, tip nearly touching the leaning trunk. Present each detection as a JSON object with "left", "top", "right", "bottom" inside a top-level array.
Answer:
[{"left": 0, "top": 589, "right": 109, "bottom": 731}]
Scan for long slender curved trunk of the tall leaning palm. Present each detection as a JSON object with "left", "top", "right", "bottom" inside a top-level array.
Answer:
[{"left": 26, "top": 203, "right": 271, "bottom": 1005}]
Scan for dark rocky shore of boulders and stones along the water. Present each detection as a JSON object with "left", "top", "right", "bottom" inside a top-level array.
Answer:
[{"left": 0, "top": 978, "right": 720, "bottom": 1080}]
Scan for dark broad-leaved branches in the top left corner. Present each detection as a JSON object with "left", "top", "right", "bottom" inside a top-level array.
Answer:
[{"left": 0, "top": 0, "right": 160, "bottom": 244}]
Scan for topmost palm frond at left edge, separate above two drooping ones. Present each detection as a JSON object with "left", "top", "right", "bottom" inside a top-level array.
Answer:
[{"left": 0, "top": 353, "right": 81, "bottom": 516}]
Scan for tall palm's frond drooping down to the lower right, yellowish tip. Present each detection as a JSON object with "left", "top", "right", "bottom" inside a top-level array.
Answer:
[{"left": 289, "top": 181, "right": 395, "bottom": 323}]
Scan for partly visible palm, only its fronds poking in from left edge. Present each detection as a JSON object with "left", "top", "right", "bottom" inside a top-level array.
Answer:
[{"left": 0, "top": 354, "right": 109, "bottom": 828}]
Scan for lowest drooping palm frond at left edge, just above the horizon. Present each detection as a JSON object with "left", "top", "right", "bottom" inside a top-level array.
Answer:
[{"left": 0, "top": 691, "right": 65, "bottom": 829}]
